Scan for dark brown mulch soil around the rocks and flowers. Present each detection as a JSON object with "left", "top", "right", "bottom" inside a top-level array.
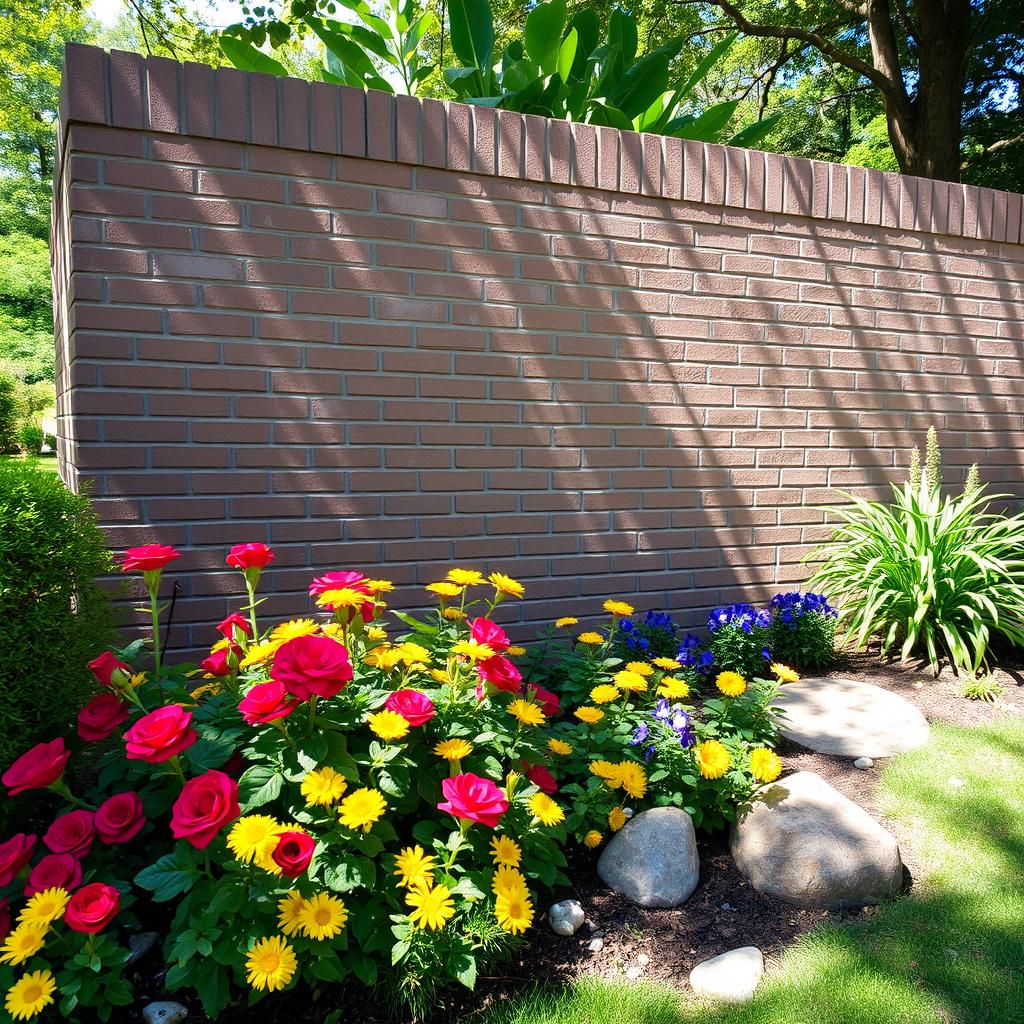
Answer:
[{"left": 121, "top": 651, "right": 1024, "bottom": 1024}]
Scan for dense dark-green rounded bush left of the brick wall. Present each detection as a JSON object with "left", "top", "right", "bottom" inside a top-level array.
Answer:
[{"left": 0, "top": 461, "right": 112, "bottom": 782}]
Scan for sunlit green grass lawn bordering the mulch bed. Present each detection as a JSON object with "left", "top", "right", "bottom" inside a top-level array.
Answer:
[{"left": 486, "top": 720, "right": 1024, "bottom": 1024}]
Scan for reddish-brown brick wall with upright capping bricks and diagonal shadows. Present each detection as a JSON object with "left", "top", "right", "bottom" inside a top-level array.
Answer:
[{"left": 54, "top": 46, "right": 1024, "bottom": 647}]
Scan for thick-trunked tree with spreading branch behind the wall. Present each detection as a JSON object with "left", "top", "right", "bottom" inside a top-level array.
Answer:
[{"left": 672, "top": 0, "right": 1024, "bottom": 181}]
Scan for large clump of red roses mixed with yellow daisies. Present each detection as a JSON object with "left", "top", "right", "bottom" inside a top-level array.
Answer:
[{"left": 0, "top": 544, "right": 567, "bottom": 1020}]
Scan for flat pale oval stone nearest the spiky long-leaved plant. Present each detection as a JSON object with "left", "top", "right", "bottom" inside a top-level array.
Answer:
[{"left": 775, "top": 677, "right": 929, "bottom": 758}]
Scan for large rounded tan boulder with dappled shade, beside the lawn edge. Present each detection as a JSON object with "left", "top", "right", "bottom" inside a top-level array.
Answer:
[{"left": 730, "top": 771, "right": 903, "bottom": 908}]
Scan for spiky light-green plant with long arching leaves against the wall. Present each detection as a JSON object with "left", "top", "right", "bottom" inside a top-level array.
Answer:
[{"left": 811, "top": 431, "right": 1024, "bottom": 673}]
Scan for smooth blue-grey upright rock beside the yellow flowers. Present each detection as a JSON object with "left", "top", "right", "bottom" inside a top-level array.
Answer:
[{"left": 597, "top": 807, "right": 700, "bottom": 907}]
